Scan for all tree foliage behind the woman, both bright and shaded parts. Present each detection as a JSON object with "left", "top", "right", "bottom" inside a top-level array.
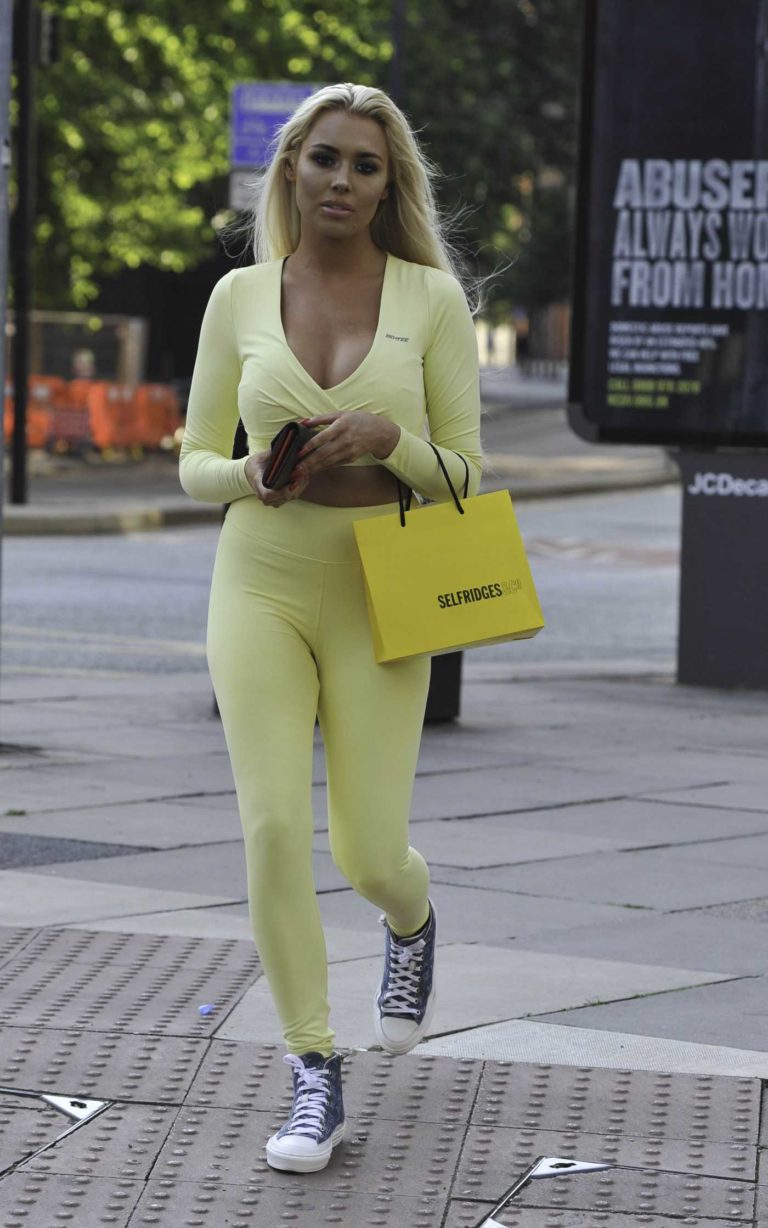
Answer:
[{"left": 17, "top": 0, "right": 581, "bottom": 307}]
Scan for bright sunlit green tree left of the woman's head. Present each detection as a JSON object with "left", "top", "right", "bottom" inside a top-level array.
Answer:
[{"left": 27, "top": 0, "right": 391, "bottom": 307}]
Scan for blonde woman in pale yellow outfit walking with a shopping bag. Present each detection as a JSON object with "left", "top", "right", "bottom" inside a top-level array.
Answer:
[{"left": 181, "top": 85, "right": 480, "bottom": 1172}]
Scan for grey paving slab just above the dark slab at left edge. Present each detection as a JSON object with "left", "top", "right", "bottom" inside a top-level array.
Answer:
[{"left": 0, "top": 795, "right": 241, "bottom": 849}]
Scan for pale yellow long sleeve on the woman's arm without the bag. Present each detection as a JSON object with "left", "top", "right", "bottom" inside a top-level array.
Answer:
[{"left": 179, "top": 271, "right": 253, "bottom": 503}]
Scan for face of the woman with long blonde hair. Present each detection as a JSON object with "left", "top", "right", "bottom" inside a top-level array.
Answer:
[{"left": 285, "top": 111, "right": 390, "bottom": 238}]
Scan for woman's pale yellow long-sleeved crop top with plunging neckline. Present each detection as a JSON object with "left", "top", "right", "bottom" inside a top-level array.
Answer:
[{"left": 179, "top": 255, "right": 482, "bottom": 503}]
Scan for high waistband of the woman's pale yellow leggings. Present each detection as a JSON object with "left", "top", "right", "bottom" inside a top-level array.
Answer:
[{"left": 225, "top": 495, "right": 397, "bottom": 562}]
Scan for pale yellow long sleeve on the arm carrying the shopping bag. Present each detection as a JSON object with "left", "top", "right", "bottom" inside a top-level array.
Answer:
[{"left": 381, "top": 269, "right": 483, "bottom": 502}]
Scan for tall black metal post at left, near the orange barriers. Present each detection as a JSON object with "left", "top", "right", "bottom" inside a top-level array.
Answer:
[{"left": 11, "top": 0, "right": 38, "bottom": 503}]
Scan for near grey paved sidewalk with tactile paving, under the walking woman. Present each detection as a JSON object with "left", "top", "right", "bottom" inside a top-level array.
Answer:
[{"left": 0, "top": 653, "right": 768, "bottom": 1228}]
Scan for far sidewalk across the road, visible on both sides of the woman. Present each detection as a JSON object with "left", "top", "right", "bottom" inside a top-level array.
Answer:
[{"left": 4, "top": 370, "right": 677, "bottom": 535}]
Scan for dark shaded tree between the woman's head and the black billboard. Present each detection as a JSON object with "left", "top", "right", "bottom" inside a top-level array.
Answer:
[{"left": 404, "top": 0, "right": 582, "bottom": 314}]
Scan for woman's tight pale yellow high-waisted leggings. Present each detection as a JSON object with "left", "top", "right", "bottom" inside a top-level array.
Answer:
[{"left": 208, "top": 497, "right": 429, "bottom": 1056}]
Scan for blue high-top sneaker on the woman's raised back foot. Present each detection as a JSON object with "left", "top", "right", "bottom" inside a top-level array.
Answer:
[{"left": 374, "top": 900, "right": 437, "bottom": 1054}]
